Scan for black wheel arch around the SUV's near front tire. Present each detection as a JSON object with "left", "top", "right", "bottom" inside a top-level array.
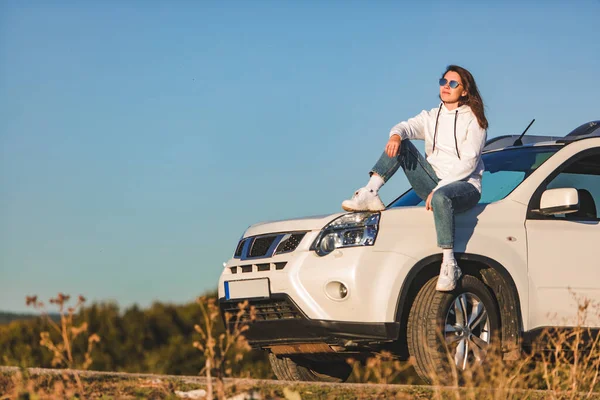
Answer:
[{"left": 395, "top": 253, "right": 523, "bottom": 359}]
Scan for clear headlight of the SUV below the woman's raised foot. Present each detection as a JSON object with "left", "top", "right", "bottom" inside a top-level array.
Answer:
[{"left": 311, "top": 212, "right": 381, "bottom": 256}]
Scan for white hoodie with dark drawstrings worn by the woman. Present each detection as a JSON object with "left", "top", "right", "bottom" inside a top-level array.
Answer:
[{"left": 390, "top": 103, "right": 487, "bottom": 193}]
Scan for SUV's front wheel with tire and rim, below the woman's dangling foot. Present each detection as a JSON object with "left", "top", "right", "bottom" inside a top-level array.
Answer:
[{"left": 407, "top": 275, "right": 500, "bottom": 384}]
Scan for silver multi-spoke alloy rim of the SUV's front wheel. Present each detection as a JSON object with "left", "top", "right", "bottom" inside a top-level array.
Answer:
[{"left": 444, "top": 293, "right": 491, "bottom": 371}]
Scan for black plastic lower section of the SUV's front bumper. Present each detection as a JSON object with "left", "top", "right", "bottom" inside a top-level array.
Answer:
[{"left": 219, "top": 293, "right": 400, "bottom": 347}]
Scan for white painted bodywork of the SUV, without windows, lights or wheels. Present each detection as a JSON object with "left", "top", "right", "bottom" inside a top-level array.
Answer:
[{"left": 218, "top": 134, "right": 600, "bottom": 350}]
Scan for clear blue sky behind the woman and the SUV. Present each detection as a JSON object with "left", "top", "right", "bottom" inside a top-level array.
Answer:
[{"left": 0, "top": 0, "right": 600, "bottom": 311}]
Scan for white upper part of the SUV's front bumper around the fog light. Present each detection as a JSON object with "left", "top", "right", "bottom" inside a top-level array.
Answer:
[{"left": 218, "top": 245, "right": 414, "bottom": 325}]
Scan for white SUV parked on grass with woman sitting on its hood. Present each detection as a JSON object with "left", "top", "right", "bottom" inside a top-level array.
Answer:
[{"left": 219, "top": 121, "right": 600, "bottom": 381}]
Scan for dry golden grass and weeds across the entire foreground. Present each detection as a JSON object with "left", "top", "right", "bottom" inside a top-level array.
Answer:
[{"left": 5, "top": 294, "right": 600, "bottom": 400}]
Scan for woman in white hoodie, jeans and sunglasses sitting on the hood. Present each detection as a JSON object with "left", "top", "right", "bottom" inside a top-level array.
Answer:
[{"left": 342, "top": 65, "right": 488, "bottom": 291}]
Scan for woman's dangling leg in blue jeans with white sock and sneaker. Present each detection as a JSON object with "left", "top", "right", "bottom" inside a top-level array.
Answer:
[{"left": 431, "top": 181, "right": 481, "bottom": 291}]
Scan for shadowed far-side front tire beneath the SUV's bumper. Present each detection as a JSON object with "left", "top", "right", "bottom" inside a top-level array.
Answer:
[{"left": 269, "top": 353, "right": 352, "bottom": 382}]
